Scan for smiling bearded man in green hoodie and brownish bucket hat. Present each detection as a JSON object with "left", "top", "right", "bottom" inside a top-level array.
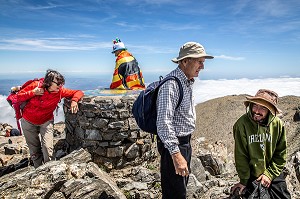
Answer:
[{"left": 231, "top": 89, "right": 291, "bottom": 199}]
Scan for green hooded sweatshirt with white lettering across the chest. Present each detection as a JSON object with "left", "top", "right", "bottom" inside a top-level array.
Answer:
[{"left": 233, "top": 111, "right": 287, "bottom": 185}]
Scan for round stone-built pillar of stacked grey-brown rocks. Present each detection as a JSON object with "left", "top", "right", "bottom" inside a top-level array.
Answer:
[{"left": 64, "top": 95, "right": 156, "bottom": 171}]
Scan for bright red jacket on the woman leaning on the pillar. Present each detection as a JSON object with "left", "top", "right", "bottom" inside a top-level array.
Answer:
[{"left": 17, "top": 79, "right": 84, "bottom": 125}]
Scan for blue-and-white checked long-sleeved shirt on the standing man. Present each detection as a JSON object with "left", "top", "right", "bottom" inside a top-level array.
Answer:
[{"left": 156, "top": 67, "right": 196, "bottom": 154}]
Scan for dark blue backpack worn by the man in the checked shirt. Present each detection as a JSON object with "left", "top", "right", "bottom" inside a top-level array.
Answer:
[{"left": 132, "top": 76, "right": 183, "bottom": 135}]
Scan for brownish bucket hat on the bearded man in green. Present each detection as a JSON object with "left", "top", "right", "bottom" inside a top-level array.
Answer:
[{"left": 244, "top": 89, "right": 282, "bottom": 115}]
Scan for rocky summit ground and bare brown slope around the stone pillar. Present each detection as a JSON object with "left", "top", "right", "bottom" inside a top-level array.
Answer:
[{"left": 0, "top": 95, "right": 300, "bottom": 199}]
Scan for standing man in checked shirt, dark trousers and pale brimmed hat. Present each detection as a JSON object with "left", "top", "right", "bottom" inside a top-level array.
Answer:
[{"left": 156, "top": 42, "right": 213, "bottom": 199}]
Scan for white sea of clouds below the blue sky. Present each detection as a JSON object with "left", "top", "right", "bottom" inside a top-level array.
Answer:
[{"left": 0, "top": 78, "right": 300, "bottom": 127}]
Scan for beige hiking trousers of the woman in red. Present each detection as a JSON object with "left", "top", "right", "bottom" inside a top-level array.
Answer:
[{"left": 21, "top": 118, "right": 54, "bottom": 168}]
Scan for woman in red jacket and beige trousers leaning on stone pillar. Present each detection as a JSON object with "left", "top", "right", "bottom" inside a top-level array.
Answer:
[{"left": 17, "top": 70, "right": 83, "bottom": 168}]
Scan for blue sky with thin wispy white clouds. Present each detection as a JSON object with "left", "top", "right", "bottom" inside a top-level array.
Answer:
[{"left": 0, "top": 0, "right": 300, "bottom": 79}]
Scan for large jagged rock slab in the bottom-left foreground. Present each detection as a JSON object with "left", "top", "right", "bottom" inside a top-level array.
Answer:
[{"left": 0, "top": 149, "right": 126, "bottom": 199}]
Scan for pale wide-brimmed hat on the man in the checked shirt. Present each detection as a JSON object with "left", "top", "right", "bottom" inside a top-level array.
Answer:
[{"left": 172, "top": 42, "right": 214, "bottom": 63}]
